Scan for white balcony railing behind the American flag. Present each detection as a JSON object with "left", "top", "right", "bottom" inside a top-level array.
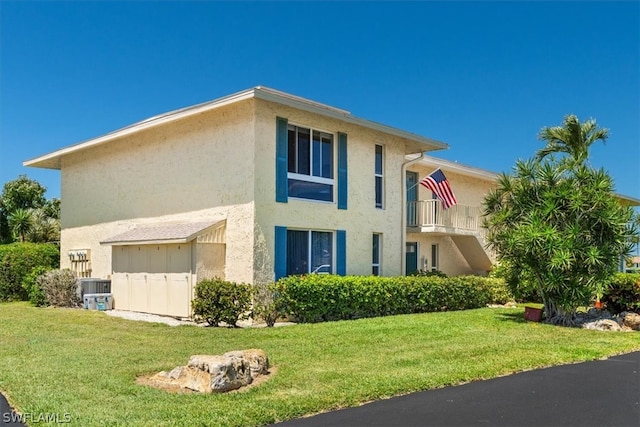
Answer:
[{"left": 407, "top": 200, "right": 482, "bottom": 232}]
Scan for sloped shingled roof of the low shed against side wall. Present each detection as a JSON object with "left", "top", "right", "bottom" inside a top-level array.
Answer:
[{"left": 100, "top": 220, "right": 225, "bottom": 246}]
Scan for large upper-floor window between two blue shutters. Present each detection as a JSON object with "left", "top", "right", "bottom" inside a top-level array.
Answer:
[{"left": 287, "top": 125, "right": 334, "bottom": 202}]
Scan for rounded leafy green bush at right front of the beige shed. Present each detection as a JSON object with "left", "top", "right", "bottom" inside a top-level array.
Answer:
[{"left": 192, "top": 279, "right": 251, "bottom": 327}]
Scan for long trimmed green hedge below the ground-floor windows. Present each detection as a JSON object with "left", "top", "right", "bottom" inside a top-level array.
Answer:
[{"left": 275, "top": 274, "right": 510, "bottom": 322}]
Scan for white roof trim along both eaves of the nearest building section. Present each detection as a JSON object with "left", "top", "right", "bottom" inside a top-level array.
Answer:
[{"left": 22, "top": 86, "right": 449, "bottom": 169}]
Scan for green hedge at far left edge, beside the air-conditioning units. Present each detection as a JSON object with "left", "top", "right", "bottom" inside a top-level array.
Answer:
[{"left": 0, "top": 243, "right": 60, "bottom": 301}]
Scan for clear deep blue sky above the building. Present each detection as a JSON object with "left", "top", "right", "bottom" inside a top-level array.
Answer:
[{"left": 0, "top": 0, "right": 640, "bottom": 198}]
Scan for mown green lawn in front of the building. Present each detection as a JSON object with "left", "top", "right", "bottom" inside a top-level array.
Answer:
[{"left": 0, "top": 303, "right": 640, "bottom": 426}]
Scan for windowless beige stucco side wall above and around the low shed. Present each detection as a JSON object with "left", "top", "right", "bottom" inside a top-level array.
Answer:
[{"left": 61, "top": 100, "right": 254, "bottom": 282}]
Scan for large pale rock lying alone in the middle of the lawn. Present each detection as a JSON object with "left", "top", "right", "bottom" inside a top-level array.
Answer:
[{"left": 150, "top": 349, "right": 269, "bottom": 393}]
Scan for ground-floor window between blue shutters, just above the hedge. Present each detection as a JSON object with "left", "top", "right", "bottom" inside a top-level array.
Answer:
[{"left": 287, "top": 230, "right": 334, "bottom": 276}]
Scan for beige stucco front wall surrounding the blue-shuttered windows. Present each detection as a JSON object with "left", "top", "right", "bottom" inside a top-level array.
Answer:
[{"left": 254, "top": 101, "right": 426, "bottom": 282}]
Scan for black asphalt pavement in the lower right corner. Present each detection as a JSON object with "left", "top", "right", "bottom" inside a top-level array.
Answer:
[{"left": 277, "top": 352, "right": 640, "bottom": 427}]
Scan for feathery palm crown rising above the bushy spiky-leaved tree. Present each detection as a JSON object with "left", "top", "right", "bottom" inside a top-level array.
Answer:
[{"left": 536, "top": 114, "right": 609, "bottom": 164}]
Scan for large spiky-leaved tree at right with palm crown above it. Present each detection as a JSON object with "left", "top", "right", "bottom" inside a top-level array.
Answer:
[{"left": 484, "top": 115, "right": 638, "bottom": 325}]
